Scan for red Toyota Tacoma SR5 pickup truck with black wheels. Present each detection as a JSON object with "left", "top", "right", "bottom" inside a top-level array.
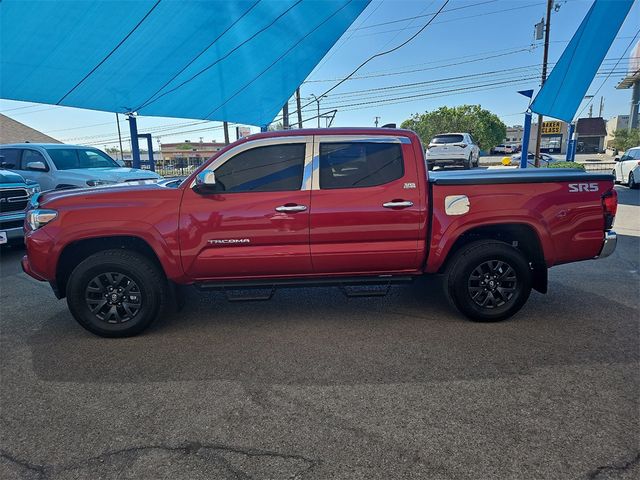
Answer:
[{"left": 22, "top": 128, "right": 617, "bottom": 337}]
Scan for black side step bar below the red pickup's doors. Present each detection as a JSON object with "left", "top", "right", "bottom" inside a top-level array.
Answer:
[{"left": 195, "top": 275, "right": 414, "bottom": 302}]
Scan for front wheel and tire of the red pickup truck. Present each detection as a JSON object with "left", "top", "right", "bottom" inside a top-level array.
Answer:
[{"left": 67, "top": 249, "right": 168, "bottom": 337}]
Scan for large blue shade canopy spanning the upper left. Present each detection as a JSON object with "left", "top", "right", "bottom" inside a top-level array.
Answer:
[{"left": 0, "top": 0, "right": 370, "bottom": 125}]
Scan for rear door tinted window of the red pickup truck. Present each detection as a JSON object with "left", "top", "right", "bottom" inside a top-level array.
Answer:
[{"left": 320, "top": 142, "right": 404, "bottom": 189}]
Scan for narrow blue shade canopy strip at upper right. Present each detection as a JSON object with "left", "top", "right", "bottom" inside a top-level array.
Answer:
[{"left": 531, "top": 0, "right": 633, "bottom": 122}]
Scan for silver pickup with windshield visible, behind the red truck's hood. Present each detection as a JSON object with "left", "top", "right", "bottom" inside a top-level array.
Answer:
[{"left": 0, "top": 143, "right": 162, "bottom": 190}]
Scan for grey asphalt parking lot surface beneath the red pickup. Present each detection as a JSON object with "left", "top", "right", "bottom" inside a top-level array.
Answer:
[{"left": 0, "top": 186, "right": 640, "bottom": 480}]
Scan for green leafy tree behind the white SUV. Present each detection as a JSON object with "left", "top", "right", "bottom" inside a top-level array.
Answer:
[{"left": 401, "top": 105, "right": 507, "bottom": 150}]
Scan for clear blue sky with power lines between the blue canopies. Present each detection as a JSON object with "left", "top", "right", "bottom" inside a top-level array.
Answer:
[{"left": 0, "top": 0, "right": 640, "bottom": 150}]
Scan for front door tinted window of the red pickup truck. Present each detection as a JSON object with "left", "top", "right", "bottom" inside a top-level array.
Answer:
[{"left": 216, "top": 143, "right": 305, "bottom": 192}]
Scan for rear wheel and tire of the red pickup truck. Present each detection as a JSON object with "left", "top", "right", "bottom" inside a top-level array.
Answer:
[{"left": 445, "top": 240, "right": 532, "bottom": 322}]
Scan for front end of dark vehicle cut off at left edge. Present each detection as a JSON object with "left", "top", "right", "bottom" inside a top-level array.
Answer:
[{"left": 0, "top": 170, "right": 40, "bottom": 245}]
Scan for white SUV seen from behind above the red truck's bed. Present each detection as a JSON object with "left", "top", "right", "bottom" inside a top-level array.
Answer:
[{"left": 426, "top": 133, "right": 480, "bottom": 170}]
